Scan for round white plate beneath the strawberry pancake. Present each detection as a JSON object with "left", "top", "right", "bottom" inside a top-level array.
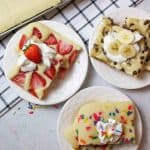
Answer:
[{"left": 3, "top": 21, "right": 88, "bottom": 105}]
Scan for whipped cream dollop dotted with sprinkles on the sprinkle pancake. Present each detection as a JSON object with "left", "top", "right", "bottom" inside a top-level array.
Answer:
[{"left": 96, "top": 118, "right": 123, "bottom": 144}]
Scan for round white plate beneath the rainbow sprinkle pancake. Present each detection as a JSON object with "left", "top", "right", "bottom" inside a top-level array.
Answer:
[{"left": 57, "top": 86, "right": 142, "bottom": 150}]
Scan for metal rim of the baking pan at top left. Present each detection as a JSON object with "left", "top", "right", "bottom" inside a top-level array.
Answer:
[{"left": 0, "top": 0, "right": 71, "bottom": 40}]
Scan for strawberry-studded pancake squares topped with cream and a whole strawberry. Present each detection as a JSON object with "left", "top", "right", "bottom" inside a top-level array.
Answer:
[{"left": 8, "top": 22, "right": 81, "bottom": 99}]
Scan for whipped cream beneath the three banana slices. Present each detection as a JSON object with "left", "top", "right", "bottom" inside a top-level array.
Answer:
[{"left": 104, "top": 31, "right": 143, "bottom": 63}]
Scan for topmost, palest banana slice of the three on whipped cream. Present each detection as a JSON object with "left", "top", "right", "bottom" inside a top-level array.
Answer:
[{"left": 117, "top": 29, "right": 134, "bottom": 44}]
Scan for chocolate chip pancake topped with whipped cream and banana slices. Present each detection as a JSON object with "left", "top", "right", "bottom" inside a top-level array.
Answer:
[{"left": 90, "top": 18, "right": 149, "bottom": 77}]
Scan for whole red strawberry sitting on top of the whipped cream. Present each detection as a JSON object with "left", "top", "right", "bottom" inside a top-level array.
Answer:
[{"left": 24, "top": 44, "right": 42, "bottom": 64}]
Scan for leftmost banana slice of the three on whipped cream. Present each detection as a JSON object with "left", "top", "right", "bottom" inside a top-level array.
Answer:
[{"left": 108, "top": 40, "right": 120, "bottom": 55}]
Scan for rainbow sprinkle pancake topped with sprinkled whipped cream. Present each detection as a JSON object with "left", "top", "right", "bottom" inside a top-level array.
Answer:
[{"left": 65, "top": 101, "right": 136, "bottom": 150}]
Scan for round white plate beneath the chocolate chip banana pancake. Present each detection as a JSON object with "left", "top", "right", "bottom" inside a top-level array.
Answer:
[{"left": 89, "top": 8, "right": 150, "bottom": 89}]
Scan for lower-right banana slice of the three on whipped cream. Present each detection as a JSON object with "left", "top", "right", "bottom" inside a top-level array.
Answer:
[{"left": 119, "top": 45, "right": 137, "bottom": 59}]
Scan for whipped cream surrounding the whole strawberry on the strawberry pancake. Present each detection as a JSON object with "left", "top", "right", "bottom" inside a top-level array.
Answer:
[{"left": 17, "top": 40, "right": 56, "bottom": 72}]
